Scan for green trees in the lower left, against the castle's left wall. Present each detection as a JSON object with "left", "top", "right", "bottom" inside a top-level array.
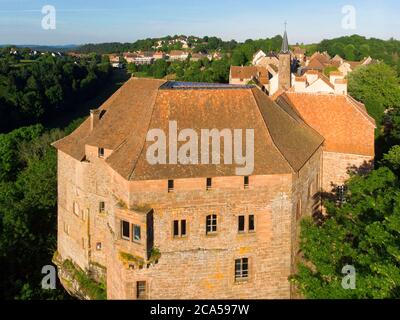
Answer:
[{"left": 0, "top": 125, "right": 68, "bottom": 299}]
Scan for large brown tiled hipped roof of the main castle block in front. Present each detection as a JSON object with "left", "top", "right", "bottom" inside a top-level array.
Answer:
[{"left": 53, "top": 78, "right": 323, "bottom": 180}]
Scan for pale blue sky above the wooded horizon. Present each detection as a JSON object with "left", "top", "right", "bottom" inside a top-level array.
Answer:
[{"left": 0, "top": 0, "right": 400, "bottom": 45}]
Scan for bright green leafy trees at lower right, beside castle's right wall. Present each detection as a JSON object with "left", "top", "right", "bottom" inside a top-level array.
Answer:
[{"left": 293, "top": 164, "right": 400, "bottom": 299}]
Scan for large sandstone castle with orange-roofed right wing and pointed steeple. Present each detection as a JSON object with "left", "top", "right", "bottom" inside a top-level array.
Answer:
[{"left": 53, "top": 31, "right": 375, "bottom": 299}]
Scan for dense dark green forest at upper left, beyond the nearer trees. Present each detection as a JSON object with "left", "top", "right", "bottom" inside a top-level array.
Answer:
[{"left": 0, "top": 53, "right": 111, "bottom": 133}]
